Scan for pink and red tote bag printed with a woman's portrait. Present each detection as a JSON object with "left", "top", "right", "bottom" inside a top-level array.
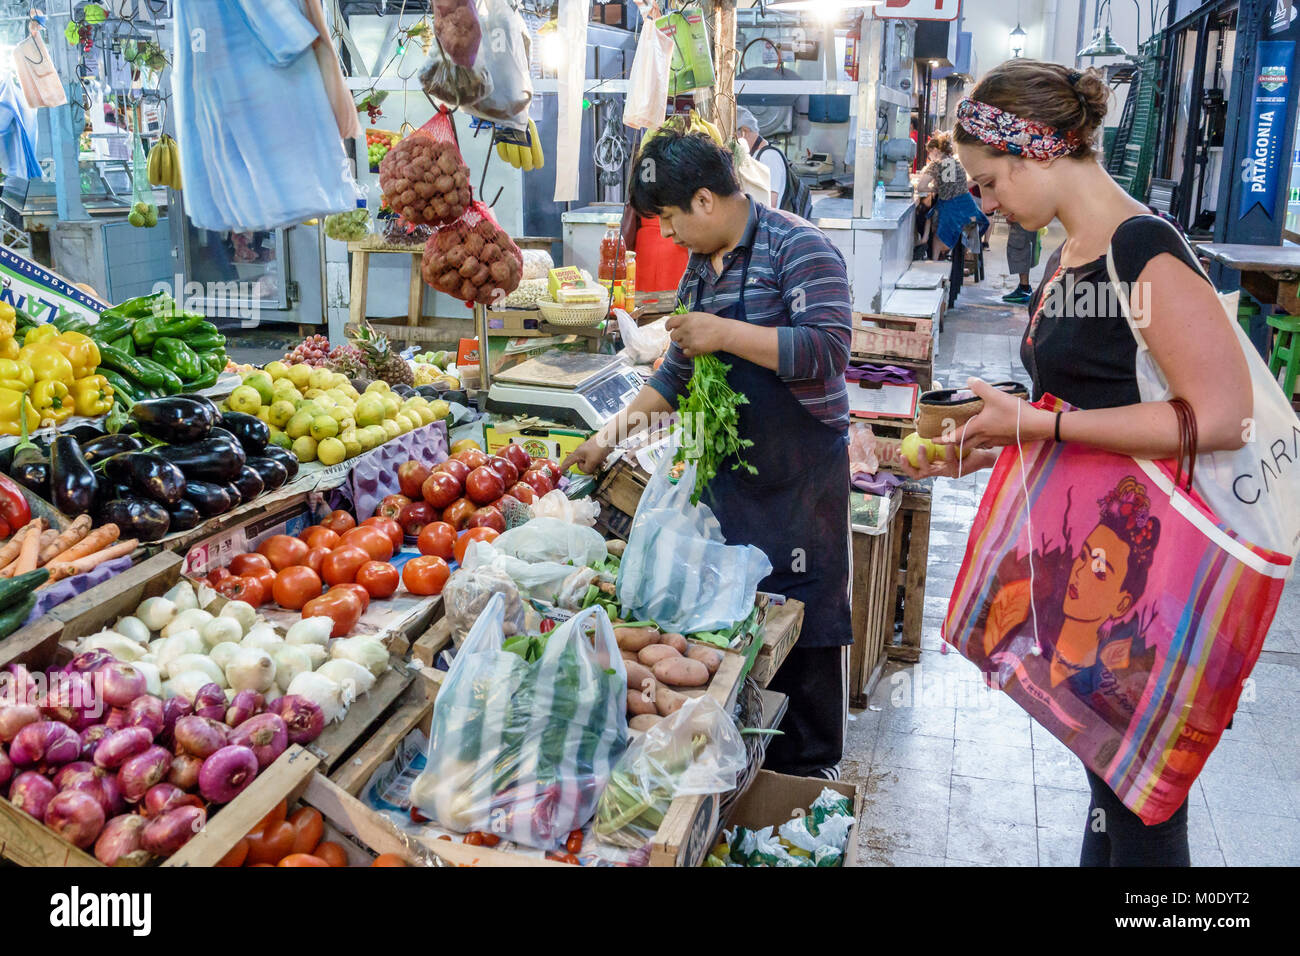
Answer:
[{"left": 943, "top": 397, "right": 1291, "bottom": 825}]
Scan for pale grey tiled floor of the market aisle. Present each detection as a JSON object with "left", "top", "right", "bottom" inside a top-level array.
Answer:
[{"left": 842, "top": 222, "right": 1300, "bottom": 866}]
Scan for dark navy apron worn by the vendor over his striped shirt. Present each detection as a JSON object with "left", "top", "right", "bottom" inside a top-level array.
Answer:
[{"left": 696, "top": 248, "right": 853, "bottom": 648}]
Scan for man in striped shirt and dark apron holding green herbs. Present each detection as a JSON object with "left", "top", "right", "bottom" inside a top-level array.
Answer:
[{"left": 564, "top": 131, "right": 853, "bottom": 779}]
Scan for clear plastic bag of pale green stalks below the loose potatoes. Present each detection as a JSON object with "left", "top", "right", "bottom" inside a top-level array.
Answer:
[{"left": 593, "top": 695, "right": 749, "bottom": 849}]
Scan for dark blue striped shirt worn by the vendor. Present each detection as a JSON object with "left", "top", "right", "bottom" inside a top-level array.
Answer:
[{"left": 650, "top": 199, "right": 853, "bottom": 429}]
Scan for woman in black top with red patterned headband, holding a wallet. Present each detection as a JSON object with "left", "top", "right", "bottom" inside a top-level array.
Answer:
[{"left": 905, "top": 59, "right": 1252, "bottom": 866}]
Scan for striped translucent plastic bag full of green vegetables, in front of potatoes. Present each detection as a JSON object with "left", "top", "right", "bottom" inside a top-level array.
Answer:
[{"left": 411, "top": 597, "right": 628, "bottom": 849}]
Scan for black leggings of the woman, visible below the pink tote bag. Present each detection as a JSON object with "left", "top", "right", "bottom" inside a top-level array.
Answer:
[{"left": 1079, "top": 770, "right": 1192, "bottom": 866}]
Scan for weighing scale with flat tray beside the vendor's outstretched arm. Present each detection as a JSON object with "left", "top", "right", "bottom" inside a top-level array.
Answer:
[{"left": 488, "top": 351, "right": 644, "bottom": 431}]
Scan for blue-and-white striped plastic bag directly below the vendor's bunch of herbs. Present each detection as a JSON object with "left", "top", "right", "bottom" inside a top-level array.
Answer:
[{"left": 618, "top": 431, "right": 772, "bottom": 633}]
